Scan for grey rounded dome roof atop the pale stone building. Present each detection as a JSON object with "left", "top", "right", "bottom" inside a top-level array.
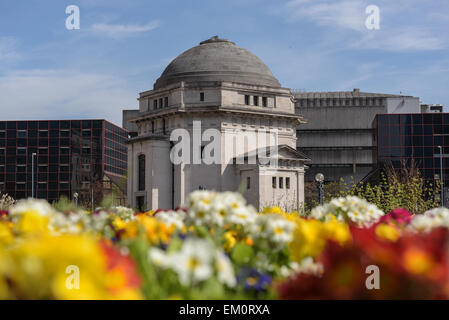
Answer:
[{"left": 154, "top": 36, "right": 281, "bottom": 89}]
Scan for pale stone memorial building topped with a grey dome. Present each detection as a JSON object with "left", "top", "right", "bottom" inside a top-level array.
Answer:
[{"left": 124, "top": 37, "right": 309, "bottom": 210}]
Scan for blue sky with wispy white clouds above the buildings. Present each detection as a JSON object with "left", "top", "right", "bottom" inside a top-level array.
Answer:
[{"left": 0, "top": 0, "right": 449, "bottom": 125}]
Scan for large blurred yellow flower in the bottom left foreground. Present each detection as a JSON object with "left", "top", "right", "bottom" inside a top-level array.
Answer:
[{"left": 8, "top": 235, "right": 109, "bottom": 299}]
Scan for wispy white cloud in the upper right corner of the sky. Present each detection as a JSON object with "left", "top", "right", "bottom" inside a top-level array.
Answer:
[{"left": 283, "top": 0, "right": 448, "bottom": 51}]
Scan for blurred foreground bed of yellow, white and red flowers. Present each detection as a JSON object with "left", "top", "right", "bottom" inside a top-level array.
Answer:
[{"left": 0, "top": 191, "right": 449, "bottom": 299}]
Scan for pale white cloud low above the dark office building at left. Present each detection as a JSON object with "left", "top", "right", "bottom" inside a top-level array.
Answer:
[{"left": 0, "top": 70, "right": 137, "bottom": 125}]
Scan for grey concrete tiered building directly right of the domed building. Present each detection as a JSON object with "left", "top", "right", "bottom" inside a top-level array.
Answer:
[{"left": 294, "top": 89, "right": 421, "bottom": 184}]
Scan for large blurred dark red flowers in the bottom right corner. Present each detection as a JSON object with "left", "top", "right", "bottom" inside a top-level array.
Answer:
[{"left": 277, "top": 227, "right": 449, "bottom": 299}]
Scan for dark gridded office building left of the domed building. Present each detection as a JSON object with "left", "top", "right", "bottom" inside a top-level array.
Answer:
[{"left": 0, "top": 120, "right": 128, "bottom": 205}]
